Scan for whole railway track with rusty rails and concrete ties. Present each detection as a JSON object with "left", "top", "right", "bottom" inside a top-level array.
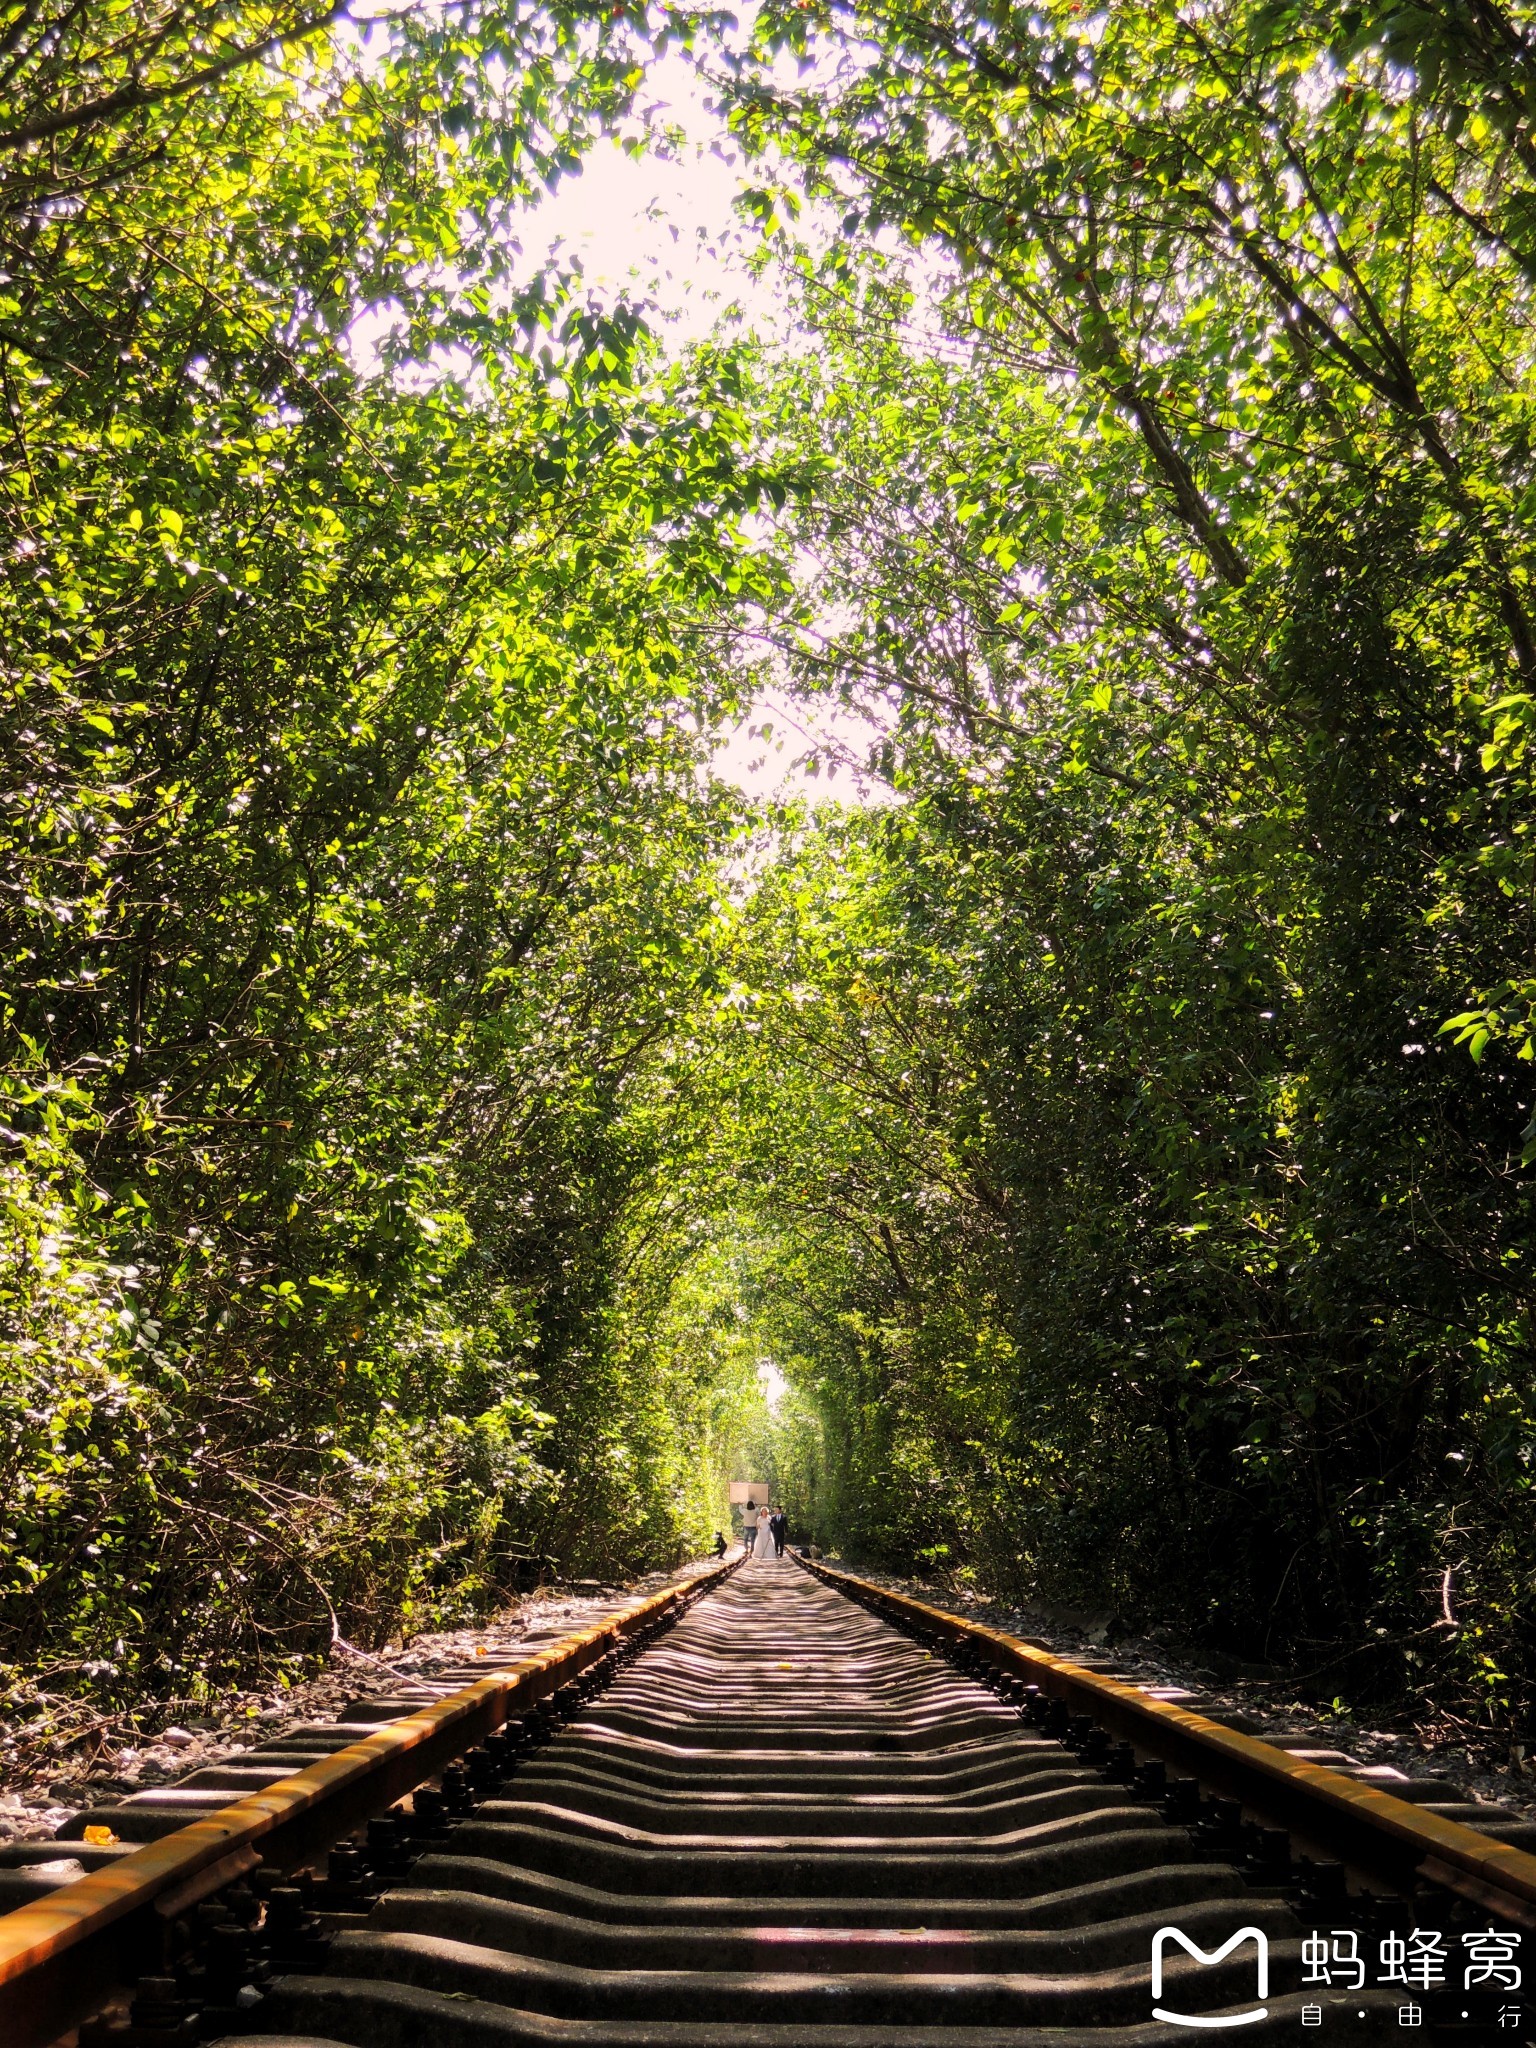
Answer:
[{"left": 0, "top": 1556, "right": 1536, "bottom": 2048}]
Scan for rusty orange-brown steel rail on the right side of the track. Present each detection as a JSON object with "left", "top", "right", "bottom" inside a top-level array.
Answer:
[{"left": 795, "top": 1554, "right": 1536, "bottom": 1927}]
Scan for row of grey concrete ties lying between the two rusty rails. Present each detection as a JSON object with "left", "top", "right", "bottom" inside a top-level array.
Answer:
[{"left": 225, "top": 1561, "right": 1399, "bottom": 2048}]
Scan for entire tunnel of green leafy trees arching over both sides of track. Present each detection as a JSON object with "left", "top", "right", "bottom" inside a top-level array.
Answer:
[{"left": 0, "top": 0, "right": 1536, "bottom": 1744}]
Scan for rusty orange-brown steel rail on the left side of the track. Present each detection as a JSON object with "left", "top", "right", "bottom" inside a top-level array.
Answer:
[{"left": 0, "top": 1559, "right": 741, "bottom": 2048}]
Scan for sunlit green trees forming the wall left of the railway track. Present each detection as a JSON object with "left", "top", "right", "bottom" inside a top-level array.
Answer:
[{"left": 0, "top": 4, "right": 772, "bottom": 1692}]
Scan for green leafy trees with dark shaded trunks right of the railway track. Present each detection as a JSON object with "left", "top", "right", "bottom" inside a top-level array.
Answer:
[{"left": 712, "top": 0, "right": 1536, "bottom": 1716}]
